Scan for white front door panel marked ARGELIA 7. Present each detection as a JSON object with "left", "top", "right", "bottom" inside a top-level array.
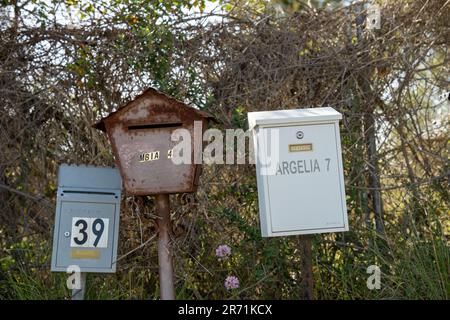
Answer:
[{"left": 263, "top": 123, "right": 347, "bottom": 235}]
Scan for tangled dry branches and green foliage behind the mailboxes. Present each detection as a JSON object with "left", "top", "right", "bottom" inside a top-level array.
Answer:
[{"left": 0, "top": 0, "right": 450, "bottom": 299}]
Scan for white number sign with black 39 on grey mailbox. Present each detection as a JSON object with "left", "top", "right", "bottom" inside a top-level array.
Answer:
[{"left": 70, "top": 217, "right": 109, "bottom": 248}]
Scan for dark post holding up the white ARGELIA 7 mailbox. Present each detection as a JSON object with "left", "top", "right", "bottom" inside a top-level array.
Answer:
[{"left": 300, "top": 235, "right": 314, "bottom": 300}]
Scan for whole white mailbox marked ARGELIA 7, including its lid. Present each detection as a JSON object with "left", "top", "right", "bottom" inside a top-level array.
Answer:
[{"left": 248, "top": 107, "right": 348, "bottom": 237}]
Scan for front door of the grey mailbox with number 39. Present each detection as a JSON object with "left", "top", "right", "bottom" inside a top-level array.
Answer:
[{"left": 54, "top": 193, "right": 120, "bottom": 272}]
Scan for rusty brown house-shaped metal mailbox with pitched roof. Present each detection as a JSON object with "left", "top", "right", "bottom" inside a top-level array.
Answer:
[{"left": 94, "top": 88, "right": 212, "bottom": 195}]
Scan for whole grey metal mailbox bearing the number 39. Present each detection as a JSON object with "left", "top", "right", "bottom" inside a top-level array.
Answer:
[{"left": 51, "top": 164, "right": 122, "bottom": 272}]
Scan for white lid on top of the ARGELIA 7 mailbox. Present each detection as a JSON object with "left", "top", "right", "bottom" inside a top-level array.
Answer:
[{"left": 248, "top": 107, "right": 342, "bottom": 129}]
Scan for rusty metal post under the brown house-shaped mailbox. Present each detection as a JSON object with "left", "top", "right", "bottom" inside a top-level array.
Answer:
[{"left": 155, "top": 194, "right": 175, "bottom": 300}]
